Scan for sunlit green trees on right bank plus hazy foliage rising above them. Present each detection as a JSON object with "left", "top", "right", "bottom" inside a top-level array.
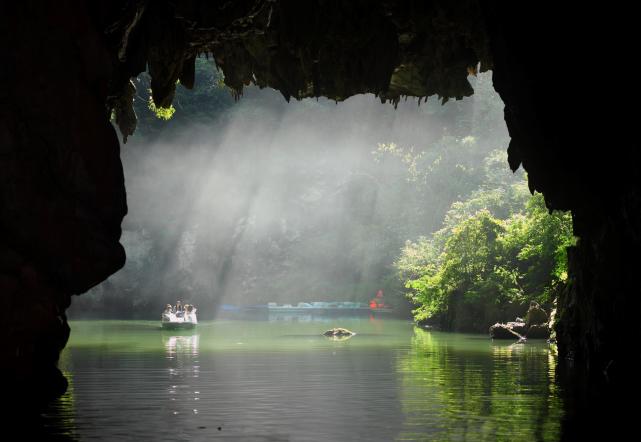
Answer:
[{"left": 374, "top": 76, "right": 574, "bottom": 331}]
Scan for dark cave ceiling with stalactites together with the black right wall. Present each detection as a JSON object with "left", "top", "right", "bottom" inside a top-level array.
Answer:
[{"left": 95, "top": 0, "right": 641, "bottom": 398}]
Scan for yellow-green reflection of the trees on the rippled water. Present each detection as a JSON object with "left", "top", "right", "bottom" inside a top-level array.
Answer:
[{"left": 397, "top": 328, "right": 562, "bottom": 440}]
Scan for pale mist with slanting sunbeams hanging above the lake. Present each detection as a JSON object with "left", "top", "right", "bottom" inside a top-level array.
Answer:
[{"left": 70, "top": 71, "right": 511, "bottom": 317}]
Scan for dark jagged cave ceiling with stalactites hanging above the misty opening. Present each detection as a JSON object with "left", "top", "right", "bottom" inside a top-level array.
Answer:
[{"left": 101, "top": 0, "right": 492, "bottom": 141}]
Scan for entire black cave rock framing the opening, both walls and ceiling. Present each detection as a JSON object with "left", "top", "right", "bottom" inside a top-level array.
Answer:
[{"left": 0, "top": 0, "right": 641, "bottom": 430}]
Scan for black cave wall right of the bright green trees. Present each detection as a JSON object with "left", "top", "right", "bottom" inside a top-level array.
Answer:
[{"left": 485, "top": 2, "right": 641, "bottom": 436}]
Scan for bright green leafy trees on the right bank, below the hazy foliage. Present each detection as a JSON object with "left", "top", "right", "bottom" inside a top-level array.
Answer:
[{"left": 396, "top": 171, "right": 574, "bottom": 330}]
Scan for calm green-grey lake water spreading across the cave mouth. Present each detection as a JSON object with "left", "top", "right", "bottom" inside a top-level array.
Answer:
[{"left": 41, "top": 318, "right": 562, "bottom": 441}]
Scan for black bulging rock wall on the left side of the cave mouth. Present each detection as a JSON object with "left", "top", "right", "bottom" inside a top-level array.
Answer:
[{"left": 0, "top": 1, "right": 127, "bottom": 398}]
